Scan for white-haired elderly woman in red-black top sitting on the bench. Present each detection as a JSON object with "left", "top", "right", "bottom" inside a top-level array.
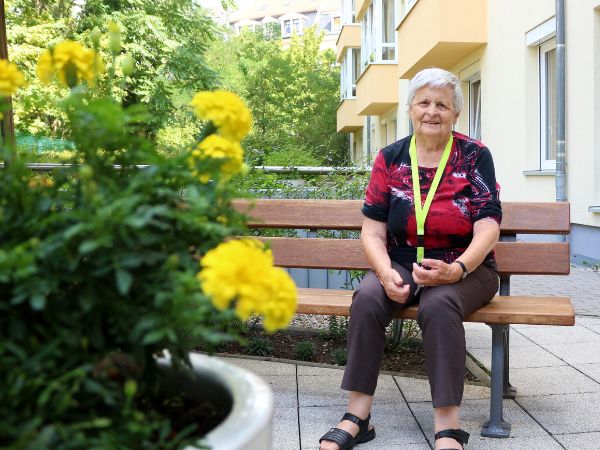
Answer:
[{"left": 319, "top": 69, "right": 502, "bottom": 450}]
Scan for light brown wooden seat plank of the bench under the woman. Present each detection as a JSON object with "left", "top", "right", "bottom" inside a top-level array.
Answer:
[{"left": 296, "top": 288, "right": 575, "bottom": 325}]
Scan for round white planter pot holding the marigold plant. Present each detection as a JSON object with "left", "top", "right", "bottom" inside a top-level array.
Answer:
[{"left": 159, "top": 353, "right": 273, "bottom": 450}]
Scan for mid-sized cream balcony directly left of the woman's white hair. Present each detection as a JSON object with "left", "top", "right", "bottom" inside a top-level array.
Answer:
[{"left": 356, "top": 63, "right": 398, "bottom": 116}]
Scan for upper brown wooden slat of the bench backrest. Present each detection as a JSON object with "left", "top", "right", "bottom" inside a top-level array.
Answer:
[{"left": 233, "top": 199, "right": 570, "bottom": 234}]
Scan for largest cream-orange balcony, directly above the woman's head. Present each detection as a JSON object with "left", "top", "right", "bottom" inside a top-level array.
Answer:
[{"left": 396, "top": 0, "right": 487, "bottom": 78}]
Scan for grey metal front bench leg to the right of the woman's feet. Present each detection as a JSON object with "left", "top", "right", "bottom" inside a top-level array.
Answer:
[{"left": 481, "top": 325, "right": 510, "bottom": 438}]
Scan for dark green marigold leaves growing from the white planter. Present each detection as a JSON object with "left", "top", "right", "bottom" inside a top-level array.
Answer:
[{"left": 0, "top": 68, "right": 243, "bottom": 449}]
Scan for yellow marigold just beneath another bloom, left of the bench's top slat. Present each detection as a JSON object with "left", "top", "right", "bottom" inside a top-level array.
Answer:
[{"left": 187, "top": 134, "right": 244, "bottom": 182}]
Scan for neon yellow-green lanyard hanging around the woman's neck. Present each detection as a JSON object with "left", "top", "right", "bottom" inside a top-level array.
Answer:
[{"left": 408, "top": 134, "right": 453, "bottom": 263}]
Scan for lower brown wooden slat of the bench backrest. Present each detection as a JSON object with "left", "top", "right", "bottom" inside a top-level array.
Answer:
[{"left": 263, "top": 238, "right": 570, "bottom": 275}]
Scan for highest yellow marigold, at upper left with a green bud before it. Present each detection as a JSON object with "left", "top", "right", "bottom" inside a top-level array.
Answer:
[{"left": 37, "top": 41, "right": 104, "bottom": 87}]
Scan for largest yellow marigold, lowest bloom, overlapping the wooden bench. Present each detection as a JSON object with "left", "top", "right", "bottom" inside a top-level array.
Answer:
[{"left": 198, "top": 239, "right": 298, "bottom": 332}]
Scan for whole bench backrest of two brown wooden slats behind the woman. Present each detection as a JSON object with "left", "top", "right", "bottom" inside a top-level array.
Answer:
[{"left": 234, "top": 199, "right": 570, "bottom": 276}]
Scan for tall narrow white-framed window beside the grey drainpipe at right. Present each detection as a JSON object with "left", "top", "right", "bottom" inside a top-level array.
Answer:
[{"left": 539, "top": 39, "right": 557, "bottom": 170}]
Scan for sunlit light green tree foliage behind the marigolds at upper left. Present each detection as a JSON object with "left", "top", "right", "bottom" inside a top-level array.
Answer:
[{"left": 7, "top": 0, "right": 216, "bottom": 146}]
